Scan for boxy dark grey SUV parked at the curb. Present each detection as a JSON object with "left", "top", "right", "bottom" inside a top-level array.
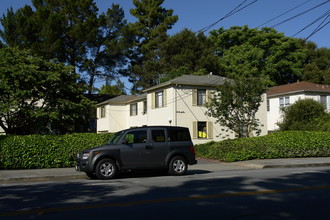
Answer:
[{"left": 76, "top": 126, "right": 197, "bottom": 179}]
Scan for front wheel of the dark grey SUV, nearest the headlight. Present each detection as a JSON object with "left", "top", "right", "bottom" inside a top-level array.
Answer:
[{"left": 95, "top": 159, "right": 117, "bottom": 180}]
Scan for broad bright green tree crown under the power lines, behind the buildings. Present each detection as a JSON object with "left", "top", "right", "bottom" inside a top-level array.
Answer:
[{"left": 210, "top": 26, "right": 306, "bottom": 85}]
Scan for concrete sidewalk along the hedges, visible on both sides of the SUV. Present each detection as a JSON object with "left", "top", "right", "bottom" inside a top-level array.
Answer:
[{"left": 0, "top": 157, "right": 330, "bottom": 184}]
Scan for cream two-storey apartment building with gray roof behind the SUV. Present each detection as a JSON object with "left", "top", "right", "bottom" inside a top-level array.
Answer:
[{"left": 96, "top": 74, "right": 267, "bottom": 144}]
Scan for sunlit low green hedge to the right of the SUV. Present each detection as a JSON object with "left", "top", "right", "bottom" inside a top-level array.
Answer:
[{"left": 195, "top": 131, "right": 330, "bottom": 162}]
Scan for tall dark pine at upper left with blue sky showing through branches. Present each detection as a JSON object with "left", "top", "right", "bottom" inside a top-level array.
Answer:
[{"left": 0, "top": 0, "right": 128, "bottom": 93}]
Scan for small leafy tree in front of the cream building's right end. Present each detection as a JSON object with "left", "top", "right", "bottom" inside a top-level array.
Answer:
[{"left": 206, "top": 74, "right": 269, "bottom": 138}]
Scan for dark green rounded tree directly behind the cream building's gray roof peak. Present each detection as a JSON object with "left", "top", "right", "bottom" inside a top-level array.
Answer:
[{"left": 159, "top": 29, "right": 223, "bottom": 81}]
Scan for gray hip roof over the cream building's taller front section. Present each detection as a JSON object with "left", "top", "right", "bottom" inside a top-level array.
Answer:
[{"left": 144, "top": 74, "right": 228, "bottom": 92}]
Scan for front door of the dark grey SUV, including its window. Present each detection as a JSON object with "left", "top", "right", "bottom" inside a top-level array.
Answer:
[{"left": 120, "top": 129, "right": 148, "bottom": 167}]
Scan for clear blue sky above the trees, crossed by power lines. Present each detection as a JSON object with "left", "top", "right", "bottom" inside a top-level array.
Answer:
[{"left": 0, "top": 0, "right": 330, "bottom": 48}]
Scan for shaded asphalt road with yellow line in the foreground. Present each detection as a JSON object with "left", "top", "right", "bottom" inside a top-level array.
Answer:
[{"left": 0, "top": 167, "right": 330, "bottom": 220}]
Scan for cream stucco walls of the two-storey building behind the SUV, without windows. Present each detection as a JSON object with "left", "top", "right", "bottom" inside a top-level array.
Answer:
[{"left": 97, "top": 86, "right": 267, "bottom": 144}]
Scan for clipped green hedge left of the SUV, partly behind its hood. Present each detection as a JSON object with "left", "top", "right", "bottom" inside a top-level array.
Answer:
[{"left": 0, "top": 133, "right": 112, "bottom": 169}]
